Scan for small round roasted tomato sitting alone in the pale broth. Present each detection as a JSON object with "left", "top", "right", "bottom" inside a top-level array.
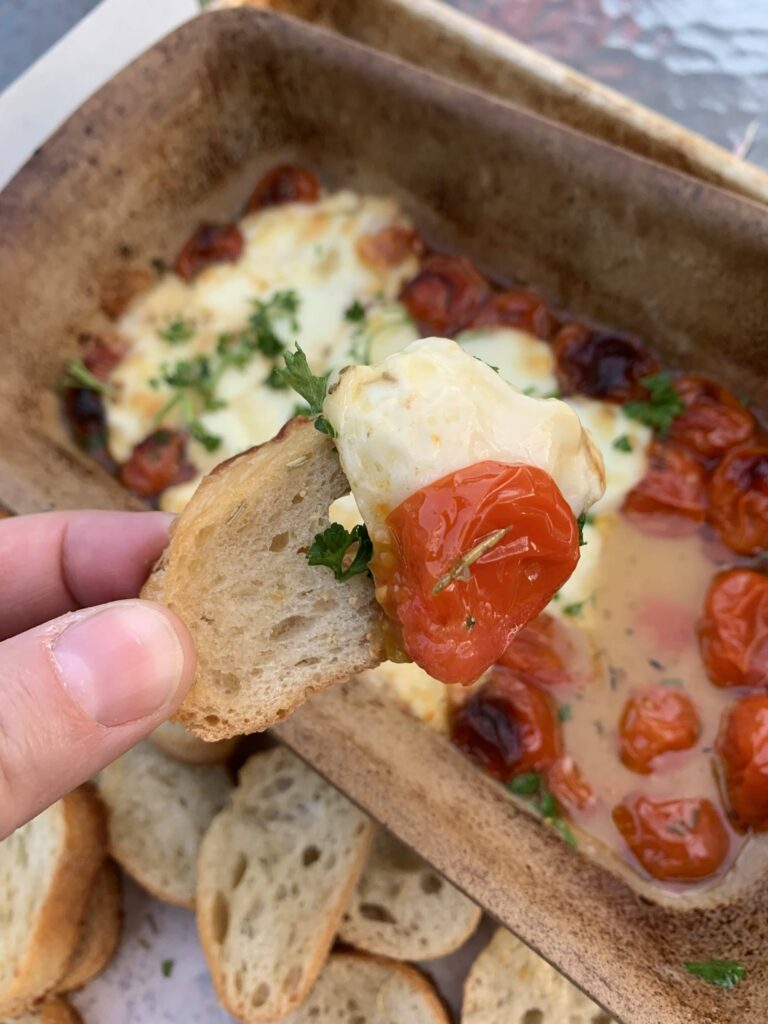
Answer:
[{"left": 618, "top": 686, "right": 701, "bottom": 775}]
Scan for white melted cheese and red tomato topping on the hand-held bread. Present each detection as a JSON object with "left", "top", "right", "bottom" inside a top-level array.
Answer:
[{"left": 324, "top": 338, "right": 603, "bottom": 684}]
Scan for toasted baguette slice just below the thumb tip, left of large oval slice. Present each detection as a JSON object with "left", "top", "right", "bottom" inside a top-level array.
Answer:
[{"left": 98, "top": 742, "right": 231, "bottom": 909}]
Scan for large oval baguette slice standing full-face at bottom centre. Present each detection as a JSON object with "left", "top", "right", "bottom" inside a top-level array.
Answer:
[{"left": 198, "top": 748, "right": 373, "bottom": 1024}]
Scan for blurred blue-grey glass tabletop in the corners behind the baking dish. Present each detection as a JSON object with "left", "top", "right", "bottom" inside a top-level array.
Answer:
[{"left": 0, "top": 0, "right": 768, "bottom": 167}]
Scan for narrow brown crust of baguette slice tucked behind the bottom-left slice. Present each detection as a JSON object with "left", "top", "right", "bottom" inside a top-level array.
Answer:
[{"left": 56, "top": 859, "right": 123, "bottom": 992}]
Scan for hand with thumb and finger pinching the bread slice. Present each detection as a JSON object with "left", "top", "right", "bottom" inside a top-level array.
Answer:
[{"left": 0, "top": 512, "right": 196, "bottom": 839}]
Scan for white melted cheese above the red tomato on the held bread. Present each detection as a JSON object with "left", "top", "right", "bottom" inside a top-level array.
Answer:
[{"left": 324, "top": 338, "right": 603, "bottom": 540}]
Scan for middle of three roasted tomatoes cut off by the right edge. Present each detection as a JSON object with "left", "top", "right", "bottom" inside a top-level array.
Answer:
[{"left": 697, "top": 569, "right": 768, "bottom": 689}]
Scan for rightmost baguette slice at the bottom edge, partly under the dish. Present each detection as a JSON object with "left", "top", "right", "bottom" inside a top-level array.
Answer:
[{"left": 462, "top": 928, "right": 612, "bottom": 1024}]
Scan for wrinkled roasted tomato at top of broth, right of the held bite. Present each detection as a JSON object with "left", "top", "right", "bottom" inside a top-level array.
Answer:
[{"left": 622, "top": 441, "right": 707, "bottom": 537}]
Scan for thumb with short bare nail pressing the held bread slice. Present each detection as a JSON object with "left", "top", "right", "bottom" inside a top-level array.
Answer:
[{"left": 0, "top": 600, "right": 195, "bottom": 839}]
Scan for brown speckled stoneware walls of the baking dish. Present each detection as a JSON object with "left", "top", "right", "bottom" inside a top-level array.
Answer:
[{"left": 0, "top": 10, "right": 768, "bottom": 1024}]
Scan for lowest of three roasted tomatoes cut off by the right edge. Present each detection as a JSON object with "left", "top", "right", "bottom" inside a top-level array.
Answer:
[{"left": 717, "top": 694, "right": 768, "bottom": 831}]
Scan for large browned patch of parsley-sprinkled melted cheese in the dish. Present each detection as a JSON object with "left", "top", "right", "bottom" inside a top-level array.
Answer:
[{"left": 105, "top": 191, "right": 417, "bottom": 511}]
